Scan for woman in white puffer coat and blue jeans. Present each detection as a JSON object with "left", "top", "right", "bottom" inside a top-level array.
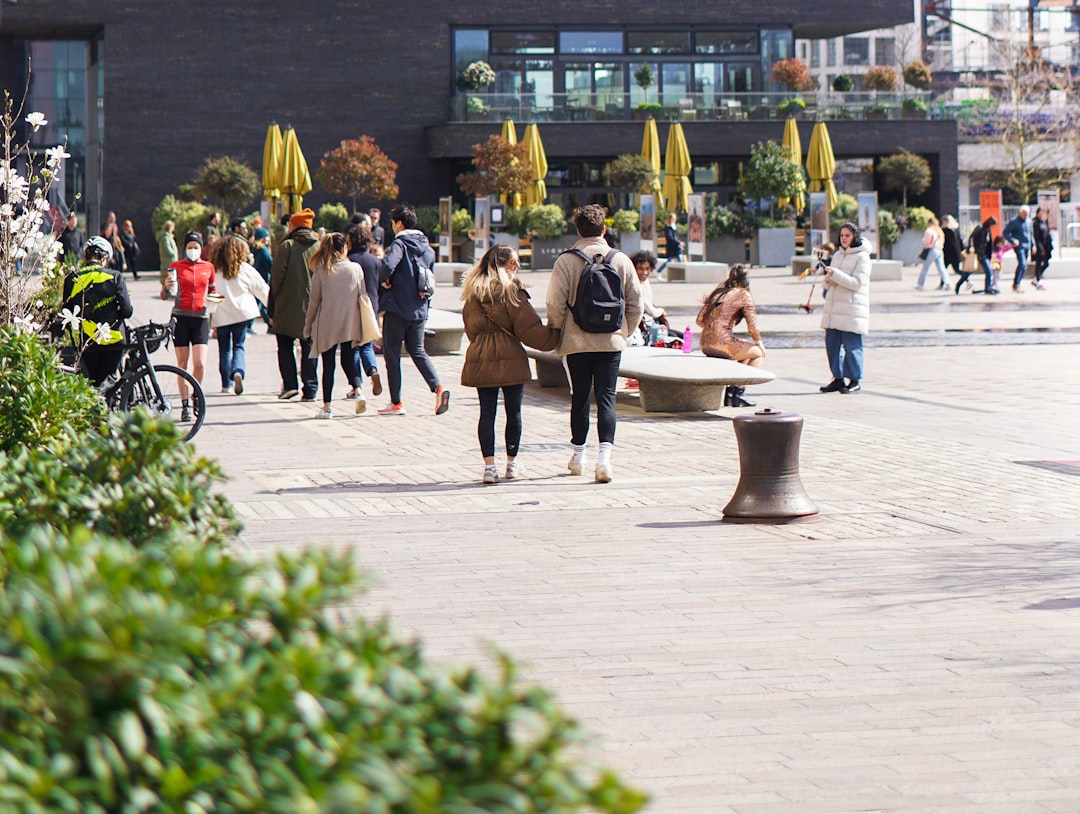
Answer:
[{"left": 820, "top": 223, "right": 870, "bottom": 393}]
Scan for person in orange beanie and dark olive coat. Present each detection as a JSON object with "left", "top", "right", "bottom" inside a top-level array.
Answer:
[{"left": 267, "top": 209, "right": 319, "bottom": 402}]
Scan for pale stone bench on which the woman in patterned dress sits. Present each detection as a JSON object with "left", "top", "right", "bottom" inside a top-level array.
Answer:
[{"left": 525, "top": 348, "right": 775, "bottom": 412}]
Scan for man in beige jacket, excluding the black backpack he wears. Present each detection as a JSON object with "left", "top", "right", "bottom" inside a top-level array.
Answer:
[{"left": 548, "top": 204, "right": 642, "bottom": 484}]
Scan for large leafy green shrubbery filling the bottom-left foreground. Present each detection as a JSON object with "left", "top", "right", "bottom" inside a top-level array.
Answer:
[{"left": 0, "top": 380, "right": 645, "bottom": 814}]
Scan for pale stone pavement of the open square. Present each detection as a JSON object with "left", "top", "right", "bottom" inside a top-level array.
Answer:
[{"left": 133, "top": 252, "right": 1080, "bottom": 814}]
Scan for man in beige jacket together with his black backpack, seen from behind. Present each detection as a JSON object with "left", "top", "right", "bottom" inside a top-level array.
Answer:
[{"left": 548, "top": 204, "right": 642, "bottom": 484}]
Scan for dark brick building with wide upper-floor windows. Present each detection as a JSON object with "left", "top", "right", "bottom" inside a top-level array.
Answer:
[{"left": 0, "top": 0, "right": 957, "bottom": 260}]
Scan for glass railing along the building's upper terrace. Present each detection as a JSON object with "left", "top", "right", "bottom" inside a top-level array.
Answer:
[{"left": 450, "top": 91, "right": 933, "bottom": 122}]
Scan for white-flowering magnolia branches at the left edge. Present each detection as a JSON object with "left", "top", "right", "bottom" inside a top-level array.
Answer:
[{"left": 0, "top": 92, "right": 71, "bottom": 330}]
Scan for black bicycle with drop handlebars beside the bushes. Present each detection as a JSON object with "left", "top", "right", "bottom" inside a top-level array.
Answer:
[{"left": 59, "top": 322, "right": 206, "bottom": 440}]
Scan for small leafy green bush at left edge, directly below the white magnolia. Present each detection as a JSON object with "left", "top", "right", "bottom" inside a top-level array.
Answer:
[{"left": 0, "top": 326, "right": 105, "bottom": 455}]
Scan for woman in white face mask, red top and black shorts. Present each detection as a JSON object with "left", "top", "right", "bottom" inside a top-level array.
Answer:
[{"left": 161, "top": 232, "right": 217, "bottom": 421}]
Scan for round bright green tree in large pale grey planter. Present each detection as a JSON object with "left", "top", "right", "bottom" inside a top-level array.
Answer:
[{"left": 739, "top": 140, "right": 804, "bottom": 266}]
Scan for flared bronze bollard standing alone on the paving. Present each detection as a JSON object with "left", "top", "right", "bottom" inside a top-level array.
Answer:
[{"left": 724, "top": 409, "right": 818, "bottom": 523}]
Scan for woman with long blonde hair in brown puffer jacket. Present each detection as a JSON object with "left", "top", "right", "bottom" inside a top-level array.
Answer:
[{"left": 461, "top": 244, "right": 559, "bottom": 484}]
